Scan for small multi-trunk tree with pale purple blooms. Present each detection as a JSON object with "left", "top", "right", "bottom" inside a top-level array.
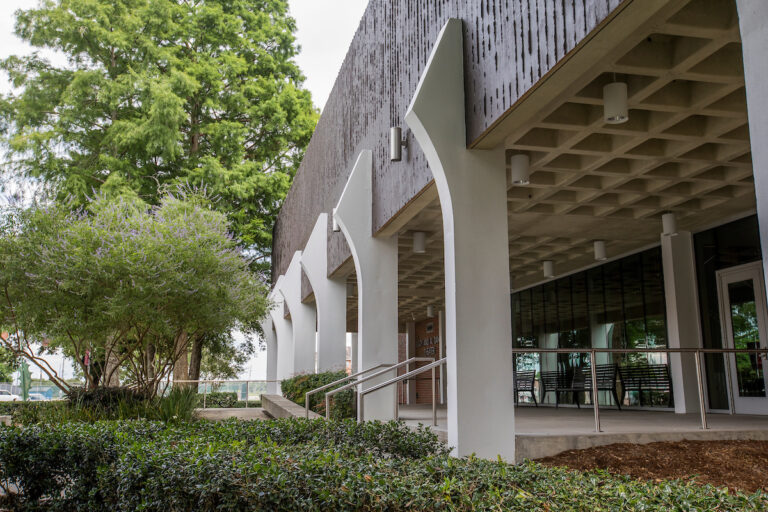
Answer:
[{"left": 0, "top": 190, "right": 266, "bottom": 394}]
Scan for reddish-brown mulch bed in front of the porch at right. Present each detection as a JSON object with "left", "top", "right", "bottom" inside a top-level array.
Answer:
[{"left": 537, "top": 441, "right": 768, "bottom": 492}]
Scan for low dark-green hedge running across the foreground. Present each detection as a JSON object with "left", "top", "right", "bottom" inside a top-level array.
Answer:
[{"left": 0, "top": 419, "right": 768, "bottom": 512}]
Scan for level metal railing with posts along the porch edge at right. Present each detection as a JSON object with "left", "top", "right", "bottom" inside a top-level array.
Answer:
[{"left": 512, "top": 347, "right": 768, "bottom": 432}]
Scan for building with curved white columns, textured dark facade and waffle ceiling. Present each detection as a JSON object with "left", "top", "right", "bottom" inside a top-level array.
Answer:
[{"left": 265, "top": 0, "right": 768, "bottom": 460}]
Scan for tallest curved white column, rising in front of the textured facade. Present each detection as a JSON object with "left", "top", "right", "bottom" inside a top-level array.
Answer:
[{"left": 405, "top": 19, "right": 515, "bottom": 461}]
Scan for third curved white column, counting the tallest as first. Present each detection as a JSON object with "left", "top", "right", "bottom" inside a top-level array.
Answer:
[{"left": 301, "top": 213, "right": 347, "bottom": 372}]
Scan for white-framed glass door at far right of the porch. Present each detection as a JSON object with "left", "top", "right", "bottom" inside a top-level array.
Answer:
[{"left": 717, "top": 261, "right": 768, "bottom": 414}]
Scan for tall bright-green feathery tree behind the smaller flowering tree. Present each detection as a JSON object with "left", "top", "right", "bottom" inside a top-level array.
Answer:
[{"left": 0, "top": 0, "right": 317, "bottom": 271}]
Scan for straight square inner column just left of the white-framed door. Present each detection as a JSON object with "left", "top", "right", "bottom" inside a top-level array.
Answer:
[{"left": 661, "top": 231, "right": 701, "bottom": 414}]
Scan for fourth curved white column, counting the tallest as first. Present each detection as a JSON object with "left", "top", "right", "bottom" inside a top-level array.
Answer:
[{"left": 280, "top": 251, "right": 317, "bottom": 374}]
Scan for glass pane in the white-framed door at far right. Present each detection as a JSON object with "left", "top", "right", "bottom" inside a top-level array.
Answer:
[{"left": 728, "top": 279, "right": 765, "bottom": 397}]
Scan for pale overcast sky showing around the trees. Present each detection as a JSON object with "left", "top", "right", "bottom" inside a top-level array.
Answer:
[{"left": 0, "top": 0, "right": 368, "bottom": 380}]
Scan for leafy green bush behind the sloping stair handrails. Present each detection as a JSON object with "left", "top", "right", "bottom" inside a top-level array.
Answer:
[{"left": 280, "top": 371, "right": 355, "bottom": 419}]
